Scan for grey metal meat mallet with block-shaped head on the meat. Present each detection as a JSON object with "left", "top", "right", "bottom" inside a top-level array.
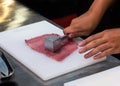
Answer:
[{"left": 44, "top": 34, "right": 68, "bottom": 52}]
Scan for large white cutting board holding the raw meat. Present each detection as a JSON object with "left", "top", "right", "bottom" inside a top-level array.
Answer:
[{"left": 0, "top": 21, "right": 105, "bottom": 80}]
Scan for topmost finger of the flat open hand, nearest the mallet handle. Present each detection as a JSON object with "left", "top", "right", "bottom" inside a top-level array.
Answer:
[{"left": 79, "top": 33, "right": 103, "bottom": 46}]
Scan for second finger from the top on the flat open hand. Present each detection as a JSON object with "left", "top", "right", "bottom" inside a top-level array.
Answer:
[{"left": 79, "top": 38, "right": 107, "bottom": 53}]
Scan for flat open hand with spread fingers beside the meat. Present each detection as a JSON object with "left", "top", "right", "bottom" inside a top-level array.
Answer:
[{"left": 79, "top": 28, "right": 120, "bottom": 59}]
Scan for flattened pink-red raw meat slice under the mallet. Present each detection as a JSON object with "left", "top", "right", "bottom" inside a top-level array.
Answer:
[{"left": 25, "top": 34, "right": 78, "bottom": 61}]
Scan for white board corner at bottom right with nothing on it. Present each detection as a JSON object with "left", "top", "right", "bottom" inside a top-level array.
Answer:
[{"left": 64, "top": 66, "right": 120, "bottom": 86}]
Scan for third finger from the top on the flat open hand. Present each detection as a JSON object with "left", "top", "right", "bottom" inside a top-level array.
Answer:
[{"left": 85, "top": 43, "right": 111, "bottom": 58}]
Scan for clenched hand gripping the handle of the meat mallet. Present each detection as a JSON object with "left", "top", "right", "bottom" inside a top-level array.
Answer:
[{"left": 64, "top": 11, "right": 99, "bottom": 38}]
